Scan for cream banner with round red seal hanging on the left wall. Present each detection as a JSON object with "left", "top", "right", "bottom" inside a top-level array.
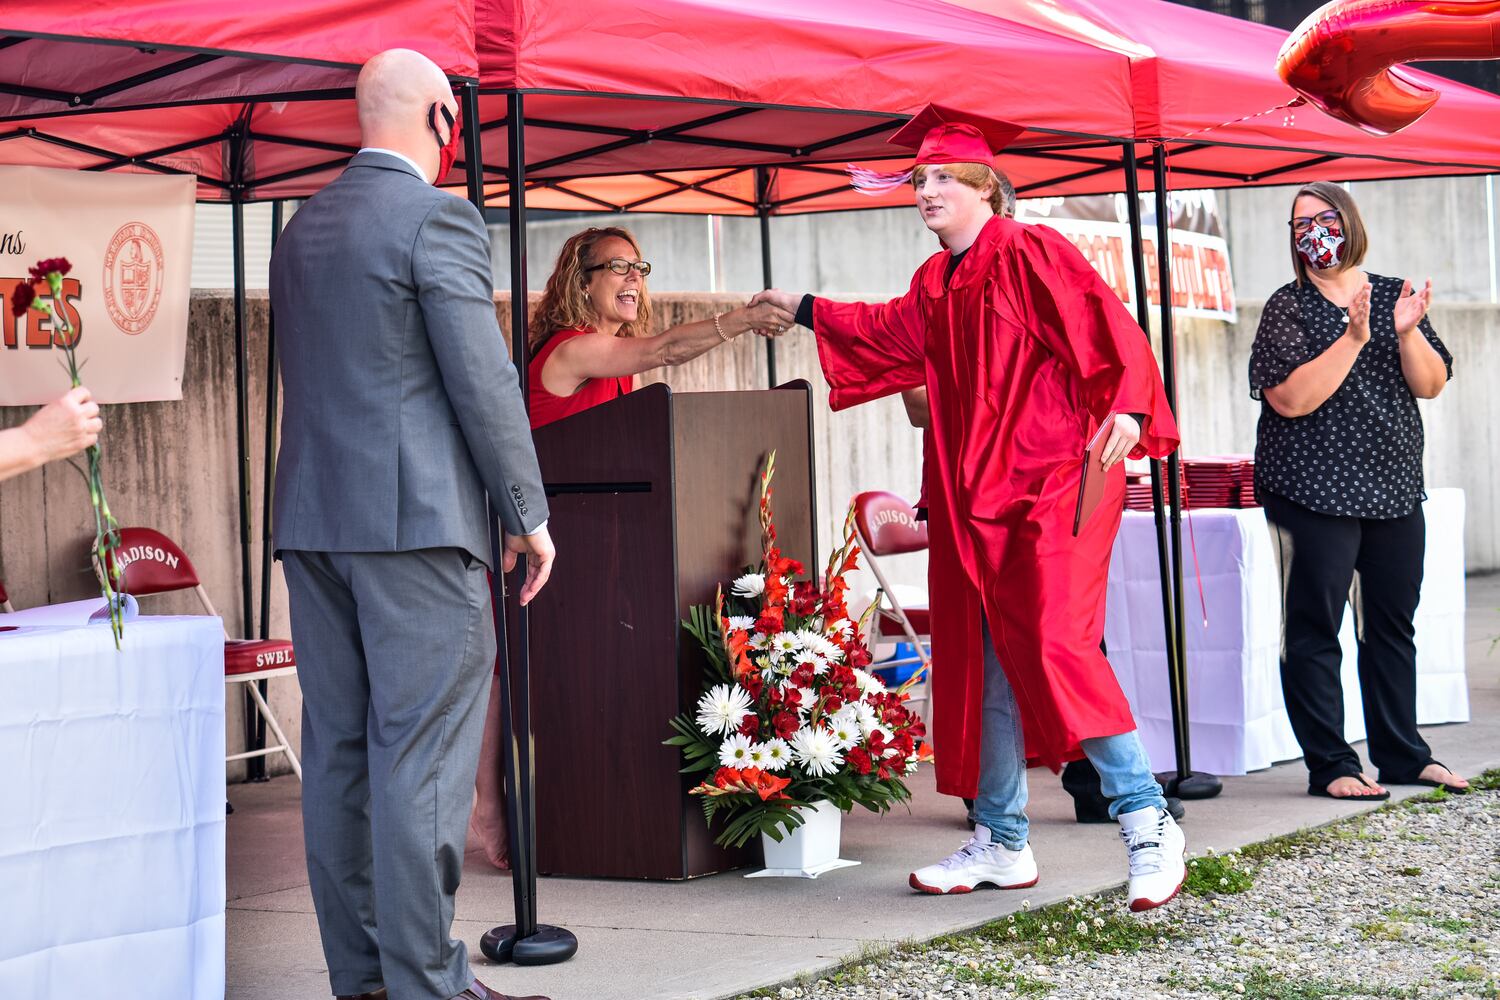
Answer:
[{"left": 0, "top": 166, "right": 197, "bottom": 406}]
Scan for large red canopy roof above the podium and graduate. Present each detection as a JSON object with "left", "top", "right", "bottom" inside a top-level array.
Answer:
[{"left": 453, "top": 0, "right": 1500, "bottom": 214}]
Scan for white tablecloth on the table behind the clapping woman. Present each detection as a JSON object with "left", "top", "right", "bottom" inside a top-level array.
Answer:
[{"left": 1104, "top": 489, "right": 1469, "bottom": 775}]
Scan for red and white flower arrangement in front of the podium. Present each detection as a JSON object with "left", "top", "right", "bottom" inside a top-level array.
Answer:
[{"left": 666, "top": 453, "right": 926, "bottom": 847}]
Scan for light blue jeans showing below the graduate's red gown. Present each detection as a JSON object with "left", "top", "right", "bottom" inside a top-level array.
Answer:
[{"left": 974, "top": 622, "right": 1167, "bottom": 850}]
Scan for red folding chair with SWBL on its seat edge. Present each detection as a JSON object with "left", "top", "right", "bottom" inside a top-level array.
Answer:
[{"left": 96, "top": 528, "right": 302, "bottom": 781}]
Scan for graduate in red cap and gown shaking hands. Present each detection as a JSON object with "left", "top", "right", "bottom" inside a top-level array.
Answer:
[{"left": 761, "top": 105, "right": 1185, "bottom": 910}]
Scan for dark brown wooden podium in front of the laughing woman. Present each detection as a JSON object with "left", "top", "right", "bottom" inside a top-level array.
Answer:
[{"left": 512, "top": 382, "right": 816, "bottom": 879}]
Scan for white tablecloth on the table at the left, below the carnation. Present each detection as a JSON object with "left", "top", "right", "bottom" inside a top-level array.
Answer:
[{"left": 0, "top": 615, "right": 225, "bottom": 1000}]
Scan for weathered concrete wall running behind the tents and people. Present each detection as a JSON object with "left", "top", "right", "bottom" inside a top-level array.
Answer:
[{"left": 0, "top": 180, "right": 1500, "bottom": 777}]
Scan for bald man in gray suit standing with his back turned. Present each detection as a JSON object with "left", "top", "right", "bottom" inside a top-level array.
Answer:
[{"left": 272, "top": 49, "right": 554, "bottom": 1000}]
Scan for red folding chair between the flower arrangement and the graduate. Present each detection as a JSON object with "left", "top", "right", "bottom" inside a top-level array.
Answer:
[{"left": 854, "top": 490, "right": 932, "bottom": 689}]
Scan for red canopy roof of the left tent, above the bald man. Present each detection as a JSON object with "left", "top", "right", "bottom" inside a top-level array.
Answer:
[{"left": 0, "top": 0, "right": 479, "bottom": 199}]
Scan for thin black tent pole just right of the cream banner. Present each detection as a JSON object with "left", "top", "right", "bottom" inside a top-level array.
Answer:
[{"left": 230, "top": 121, "right": 267, "bottom": 781}]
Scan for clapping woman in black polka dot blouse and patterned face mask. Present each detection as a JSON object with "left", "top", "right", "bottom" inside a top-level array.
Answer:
[{"left": 1250, "top": 181, "right": 1469, "bottom": 799}]
